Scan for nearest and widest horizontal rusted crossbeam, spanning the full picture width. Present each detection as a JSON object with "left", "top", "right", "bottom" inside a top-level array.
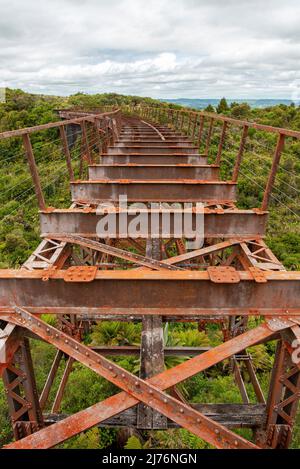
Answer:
[{"left": 0, "top": 269, "right": 300, "bottom": 317}]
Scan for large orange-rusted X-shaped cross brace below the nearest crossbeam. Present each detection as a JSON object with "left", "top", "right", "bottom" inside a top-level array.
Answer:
[{"left": 3, "top": 308, "right": 289, "bottom": 448}]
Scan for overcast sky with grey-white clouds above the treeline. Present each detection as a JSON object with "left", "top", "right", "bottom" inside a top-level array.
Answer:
[{"left": 0, "top": 0, "right": 300, "bottom": 99}]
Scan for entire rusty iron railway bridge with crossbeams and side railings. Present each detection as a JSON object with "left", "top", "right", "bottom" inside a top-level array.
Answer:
[{"left": 0, "top": 106, "right": 300, "bottom": 449}]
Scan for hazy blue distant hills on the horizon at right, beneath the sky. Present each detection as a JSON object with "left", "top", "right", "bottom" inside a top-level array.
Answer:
[{"left": 160, "top": 98, "right": 293, "bottom": 109}]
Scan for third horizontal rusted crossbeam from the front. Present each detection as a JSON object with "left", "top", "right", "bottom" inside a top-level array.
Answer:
[{"left": 71, "top": 179, "right": 236, "bottom": 203}]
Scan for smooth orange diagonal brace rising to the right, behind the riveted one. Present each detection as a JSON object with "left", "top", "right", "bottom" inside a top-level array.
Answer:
[{"left": 2, "top": 316, "right": 286, "bottom": 449}]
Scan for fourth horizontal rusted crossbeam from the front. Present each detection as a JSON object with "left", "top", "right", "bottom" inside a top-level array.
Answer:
[{"left": 89, "top": 164, "right": 219, "bottom": 181}]
